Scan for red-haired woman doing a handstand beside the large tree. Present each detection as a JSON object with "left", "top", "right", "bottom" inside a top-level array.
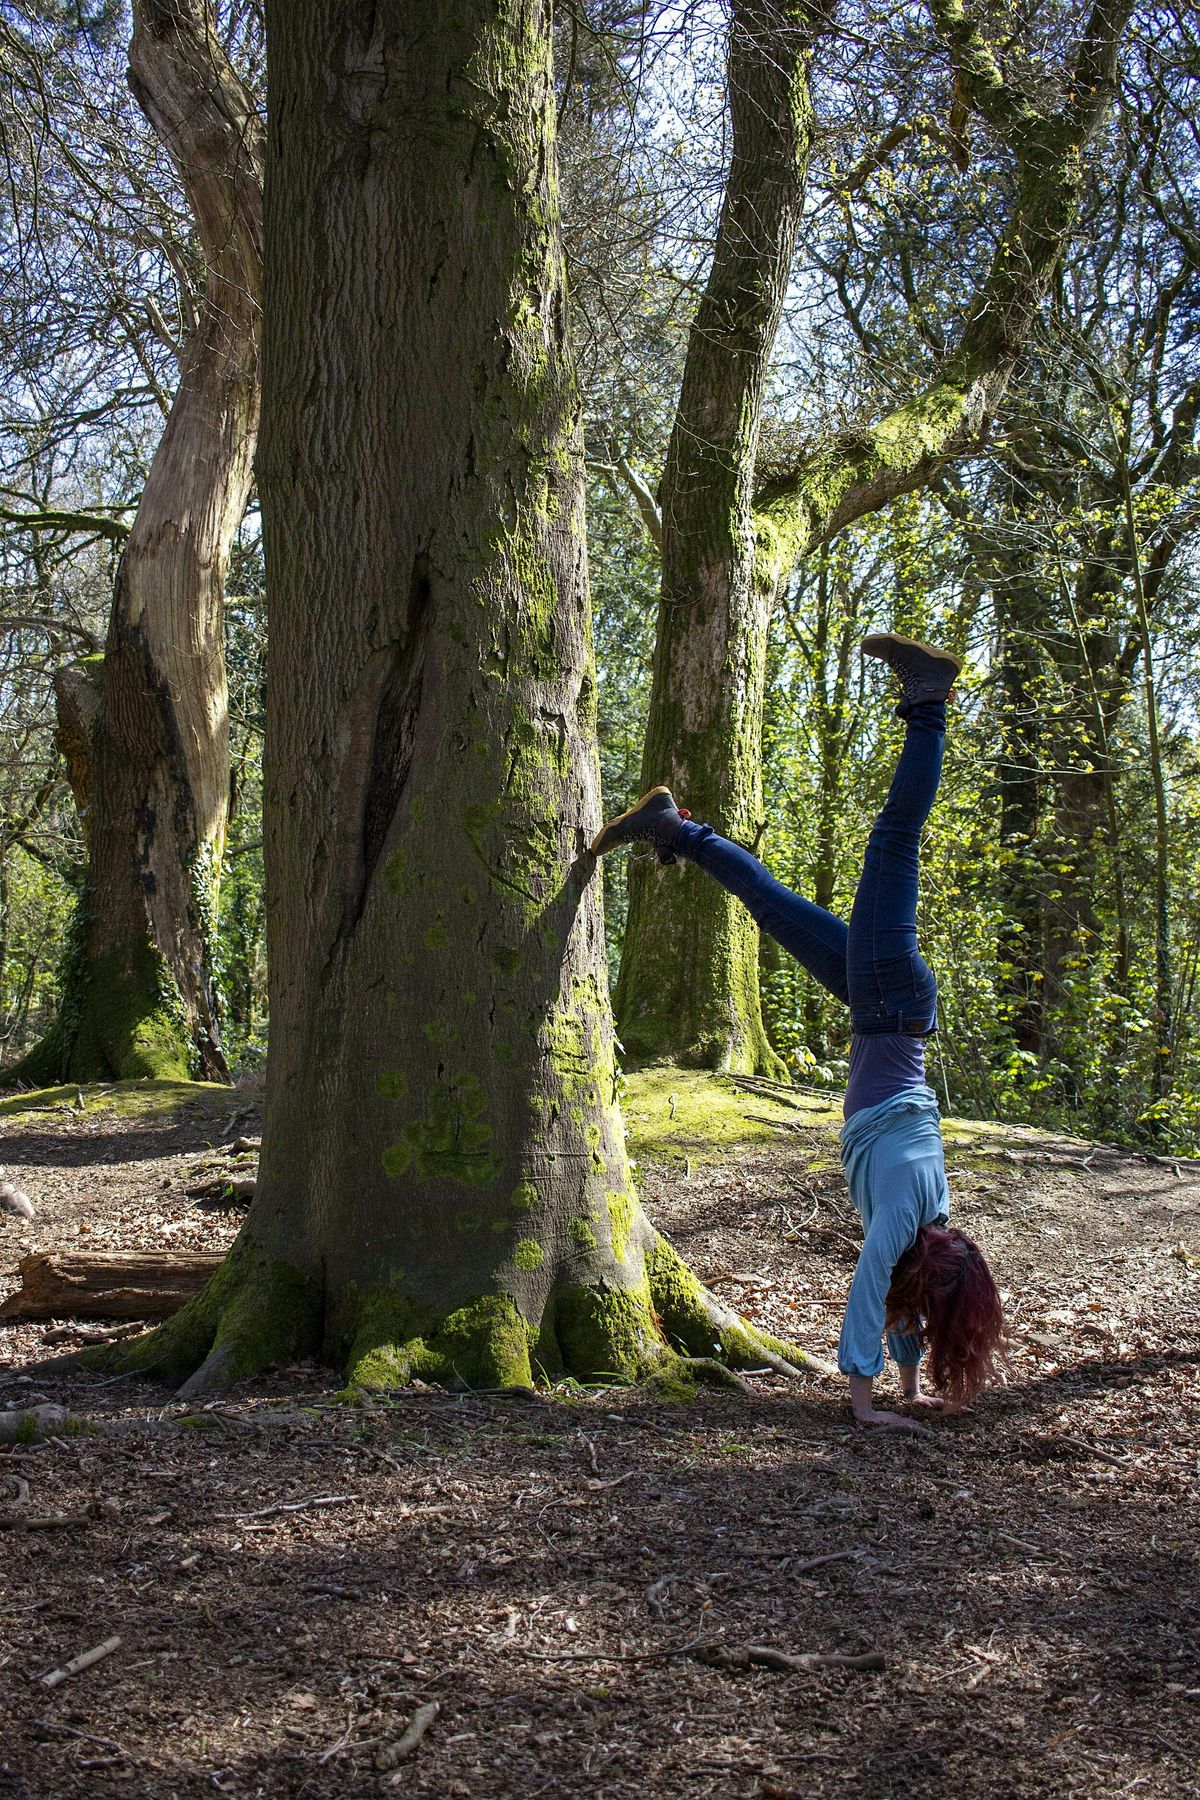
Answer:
[{"left": 592, "top": 632, "right": 1004, "bottom": 1427}]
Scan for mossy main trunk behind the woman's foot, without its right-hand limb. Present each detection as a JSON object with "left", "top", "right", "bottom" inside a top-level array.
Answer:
[{"left": 615, "top": 0, "right": 828, "bottom": 1075}]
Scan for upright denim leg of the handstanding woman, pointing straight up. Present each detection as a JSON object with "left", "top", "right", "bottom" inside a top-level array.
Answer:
[{"left": 846, "top": 700, "right": 946, "bottom": 1030}]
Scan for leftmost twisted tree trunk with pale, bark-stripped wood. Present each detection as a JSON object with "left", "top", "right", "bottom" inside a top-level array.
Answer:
[{"left": 13, "top": 0, "right": 263, "bottom": 1080}]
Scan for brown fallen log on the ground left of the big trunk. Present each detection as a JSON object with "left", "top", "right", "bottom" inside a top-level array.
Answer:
[{"left": 0, "top": 1249, "right": 221, "bottom": 1319}]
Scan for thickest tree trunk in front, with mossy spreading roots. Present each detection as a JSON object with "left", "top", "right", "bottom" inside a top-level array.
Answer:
[{"left": 103, "top": 0, "right": 827, "bottom": 1391}]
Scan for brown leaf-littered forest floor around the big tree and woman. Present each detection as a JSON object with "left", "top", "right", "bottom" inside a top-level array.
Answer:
[{"left": 0, "top": 1075, "right": 1200, "bottom": 1800}]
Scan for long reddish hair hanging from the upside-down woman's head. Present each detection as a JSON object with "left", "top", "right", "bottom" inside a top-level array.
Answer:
[{"left": 887, "top": 1226, "right": 1004, "bottom": 1406}]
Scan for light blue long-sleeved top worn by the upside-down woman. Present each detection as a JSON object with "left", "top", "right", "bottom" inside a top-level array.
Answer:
[{"left": 838, "top": 1087, "right": 950, "bottom": 1375}]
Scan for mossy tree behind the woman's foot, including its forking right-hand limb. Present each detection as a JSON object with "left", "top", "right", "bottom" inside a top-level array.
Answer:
[{"left": 617, "top": 0, "right": 1132, "bottom": 1067}]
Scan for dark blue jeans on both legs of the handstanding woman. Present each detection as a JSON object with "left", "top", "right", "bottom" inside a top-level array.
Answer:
[{"left": 673, "top": 700, "right": 946, "bottom": 1037}]
